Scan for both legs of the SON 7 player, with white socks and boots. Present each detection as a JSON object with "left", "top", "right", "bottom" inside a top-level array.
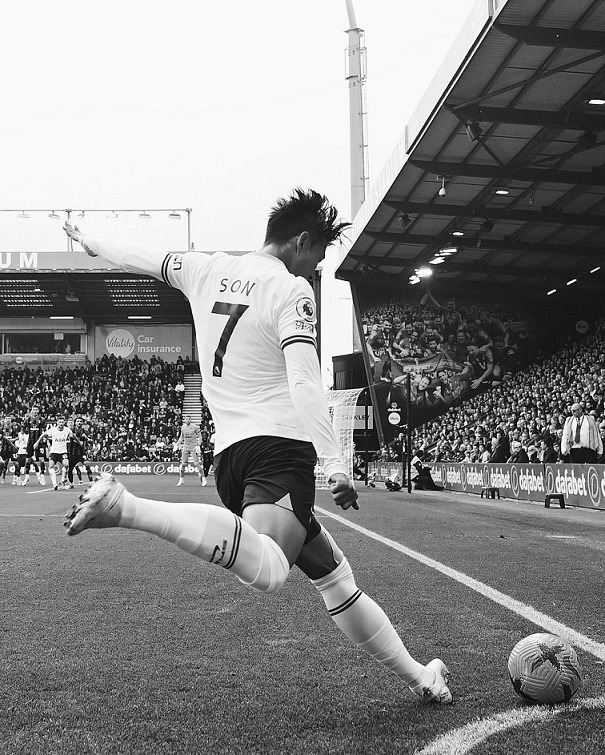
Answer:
[{"left": 65, "top": 474, "right": 452, "bottom": 704}]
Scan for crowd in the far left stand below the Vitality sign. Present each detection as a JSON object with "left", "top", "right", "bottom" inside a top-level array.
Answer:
[{"left": 0, "top": 356, "right": 212, "bottom": 461}]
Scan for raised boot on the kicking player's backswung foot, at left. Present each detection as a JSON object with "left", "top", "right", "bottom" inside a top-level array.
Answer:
[{"left": 63, "top": 472, "right": 125, "bottom": 535}]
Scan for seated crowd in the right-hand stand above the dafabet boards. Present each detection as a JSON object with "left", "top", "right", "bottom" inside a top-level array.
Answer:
[{"left": 413, "top": 323, "right": 605, "bottom": 463}]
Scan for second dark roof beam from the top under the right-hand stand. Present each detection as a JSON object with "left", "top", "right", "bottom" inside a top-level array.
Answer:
[{"left": 448, "top": 105, "right": 605, "bottom": 132}]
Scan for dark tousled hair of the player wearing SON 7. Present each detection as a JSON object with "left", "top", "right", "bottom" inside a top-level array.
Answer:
[{"left": 265, "top": 189, "right": 351, "bottom": 245}]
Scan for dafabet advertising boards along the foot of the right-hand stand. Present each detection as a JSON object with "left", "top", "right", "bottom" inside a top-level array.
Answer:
[{"left": 369, "top": 462, "right": 605, "bottom": 510}]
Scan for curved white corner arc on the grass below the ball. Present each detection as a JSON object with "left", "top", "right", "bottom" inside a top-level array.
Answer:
[{"left": 414, "top": 697, "right": 605, "bottom": 755}]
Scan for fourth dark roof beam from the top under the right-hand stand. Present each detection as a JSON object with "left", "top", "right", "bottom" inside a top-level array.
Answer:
[{"left": 385, "top": 200, "right": 605, "bottom": 228}]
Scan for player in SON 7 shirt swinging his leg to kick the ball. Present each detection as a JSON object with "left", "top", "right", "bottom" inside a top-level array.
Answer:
[{"left": 64, "top": 189, "right": 452, "bottom": 703}]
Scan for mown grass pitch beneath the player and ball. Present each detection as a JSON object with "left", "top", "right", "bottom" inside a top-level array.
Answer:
[{"left": 0, "top": 476, "right": 605, "bottom": 755}]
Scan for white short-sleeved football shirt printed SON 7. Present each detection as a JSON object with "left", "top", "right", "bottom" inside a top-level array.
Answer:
[{"left": 162, "top": 253, "right": 316, "bottom": 453}]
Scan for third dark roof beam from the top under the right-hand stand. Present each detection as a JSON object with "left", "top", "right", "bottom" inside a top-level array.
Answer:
[{"left": 408, "top": 158, "right": 605, "bottom": 186}]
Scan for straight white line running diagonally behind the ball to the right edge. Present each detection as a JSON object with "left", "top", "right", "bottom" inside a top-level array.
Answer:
[{"left": 316, "top": 508, "right": 605, "bottom": 661}]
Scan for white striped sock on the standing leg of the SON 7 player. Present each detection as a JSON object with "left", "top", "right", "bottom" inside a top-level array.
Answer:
[{"left": 311, "top": 558, "right": 434, "bottom": 694}]
